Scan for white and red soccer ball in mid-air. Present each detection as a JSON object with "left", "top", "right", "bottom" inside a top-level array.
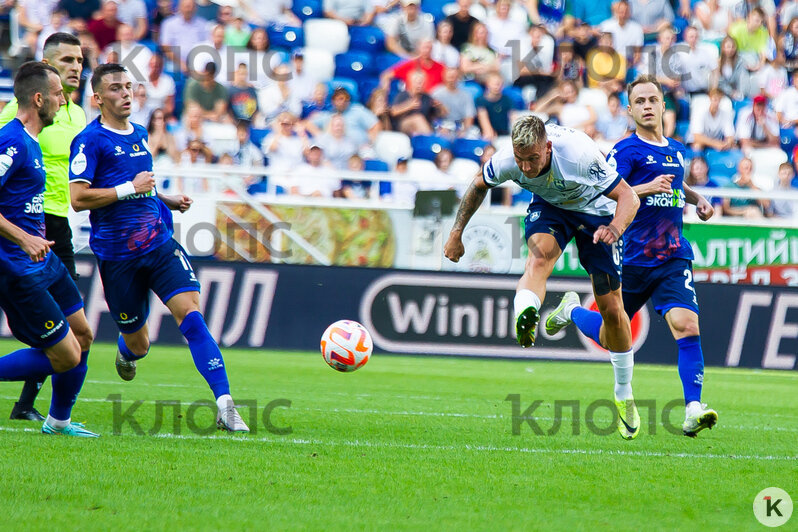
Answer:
[{"left": 321, "top": 320, "right": 374, "bottom": 372}]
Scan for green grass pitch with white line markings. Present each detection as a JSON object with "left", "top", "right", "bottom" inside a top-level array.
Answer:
[{"left": 0, "top": 341, "right": 798, "bottom": 530}]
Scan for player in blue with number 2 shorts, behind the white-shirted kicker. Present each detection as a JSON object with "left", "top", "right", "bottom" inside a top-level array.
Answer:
[{"left": 546, "top": 76, "right": 718, "bottom": 437}]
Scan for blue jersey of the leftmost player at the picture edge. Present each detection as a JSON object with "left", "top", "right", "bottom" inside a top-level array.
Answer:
[{"left": 0, "top": 118, "right": 49, "bottom": 276}]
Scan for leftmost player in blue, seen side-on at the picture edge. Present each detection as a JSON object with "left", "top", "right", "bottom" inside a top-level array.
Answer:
[{"left": 0, "top": 62, "right": 97, "bottom": 437}]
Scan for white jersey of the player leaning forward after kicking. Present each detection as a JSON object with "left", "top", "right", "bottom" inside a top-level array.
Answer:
[{"left": 482, "top": 125, "right": 621, "bottom": 216}]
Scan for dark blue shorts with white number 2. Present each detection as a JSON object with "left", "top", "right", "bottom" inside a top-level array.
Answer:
[{"left": 622, "top": 259, "right": 698, "bottom": 317}]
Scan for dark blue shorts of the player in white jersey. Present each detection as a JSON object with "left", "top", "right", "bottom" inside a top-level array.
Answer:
[{"left": 524, "top": 196, "right": 623, "bottom": 281}]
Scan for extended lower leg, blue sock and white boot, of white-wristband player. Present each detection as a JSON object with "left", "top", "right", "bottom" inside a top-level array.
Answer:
[{"left": 180, "top": 310, "right": 249, "bottom": 432}]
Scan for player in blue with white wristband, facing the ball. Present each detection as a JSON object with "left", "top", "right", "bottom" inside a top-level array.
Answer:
[{"left": 69, "top": 63, "right": 249, "bottom": 432}]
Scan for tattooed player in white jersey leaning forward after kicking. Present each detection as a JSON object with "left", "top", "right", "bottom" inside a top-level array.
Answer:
[{"left": 444, "top": 116, "right": 640, "bottom": 429}]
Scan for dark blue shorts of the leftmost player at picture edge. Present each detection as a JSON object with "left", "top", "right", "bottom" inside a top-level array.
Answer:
[{"left": 0, "top": 252, "right": 83, "bottom": 349}]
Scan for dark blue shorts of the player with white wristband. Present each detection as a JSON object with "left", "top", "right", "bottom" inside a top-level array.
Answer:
[{"left": 97, "top": 238, "right": 200, "bottom": 334}]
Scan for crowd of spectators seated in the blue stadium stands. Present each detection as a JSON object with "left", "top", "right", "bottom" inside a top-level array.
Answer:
[{"left": 6, "top": 0, "right": 798, "bottom": 217}]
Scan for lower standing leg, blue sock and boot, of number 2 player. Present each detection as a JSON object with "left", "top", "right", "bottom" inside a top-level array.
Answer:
[{"left": 676, "top": 335, "right": 718, "bottom": 438}]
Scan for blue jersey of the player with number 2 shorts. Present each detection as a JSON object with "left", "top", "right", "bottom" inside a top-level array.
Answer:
[{"left": 607, "top": 134, "right": 693, "bottom": 266}]
